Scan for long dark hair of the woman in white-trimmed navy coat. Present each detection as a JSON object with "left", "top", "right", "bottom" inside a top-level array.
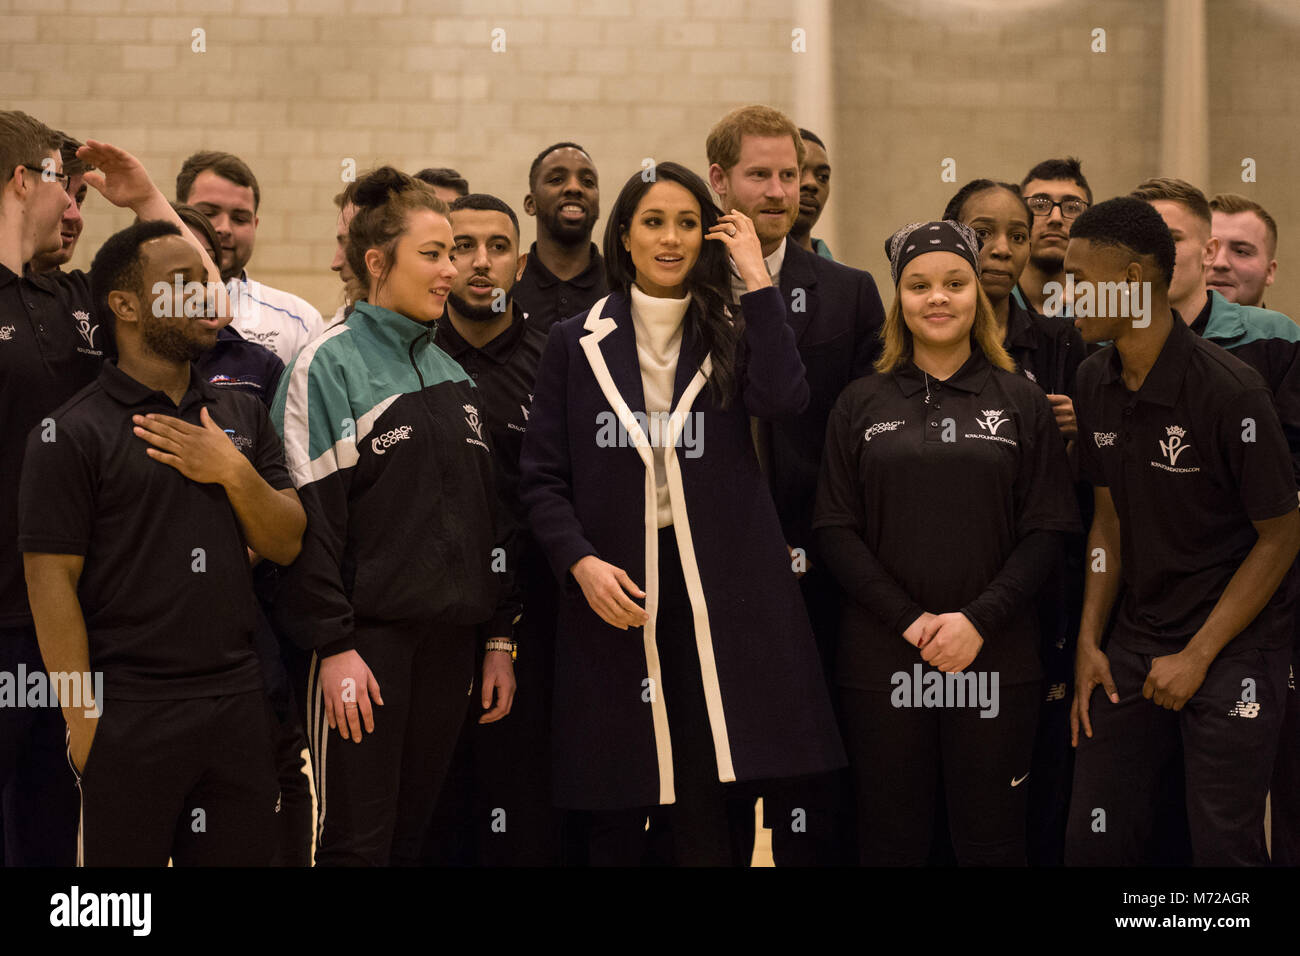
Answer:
[{"left": 605, "top": 163, "right": 744, "bottom": 408}]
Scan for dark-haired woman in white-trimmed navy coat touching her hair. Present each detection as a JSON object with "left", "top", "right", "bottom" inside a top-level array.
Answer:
[{"left": 520, "top": 163, "right": 845, "bottom": 865}]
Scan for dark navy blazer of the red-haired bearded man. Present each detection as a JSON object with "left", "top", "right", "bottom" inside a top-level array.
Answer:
[{"left": 768, "top": 239, "right": 885, "bottom": 566}]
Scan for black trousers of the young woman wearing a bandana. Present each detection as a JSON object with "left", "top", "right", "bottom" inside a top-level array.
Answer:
[{"left": 840, "top": 683, "right": 1040, "bottom": 866}]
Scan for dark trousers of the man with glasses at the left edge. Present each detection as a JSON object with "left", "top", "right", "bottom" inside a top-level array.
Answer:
[{"left": 0, "top": 627, "right": 79, "bottom": 866}]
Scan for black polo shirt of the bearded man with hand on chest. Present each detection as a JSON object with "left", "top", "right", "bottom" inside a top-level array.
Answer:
[{"left": 18, "top": 360, "right": 293, "bottom": 700}]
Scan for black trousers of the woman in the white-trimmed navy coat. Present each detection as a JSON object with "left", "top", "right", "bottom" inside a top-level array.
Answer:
[{"left": 589, "top": 525, "right": 759, "bottom": 866}]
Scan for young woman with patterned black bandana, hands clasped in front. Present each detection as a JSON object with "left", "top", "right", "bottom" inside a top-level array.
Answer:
[{"left": 814, "top": 221, "right": 1078, "bottom": 865}]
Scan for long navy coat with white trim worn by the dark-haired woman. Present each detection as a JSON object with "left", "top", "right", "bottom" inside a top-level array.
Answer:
[{"left": 520, "top": 289, "right": 845, "bottom": 809}]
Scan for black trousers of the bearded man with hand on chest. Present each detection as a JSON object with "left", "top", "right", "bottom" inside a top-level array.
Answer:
[{"left": 78, "top": 689, "right": 278, "bottom": 866}]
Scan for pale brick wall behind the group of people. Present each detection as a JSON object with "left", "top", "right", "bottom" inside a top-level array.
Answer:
[{"left": 0, "top": 0, "right": 1300, "bottom": 321}]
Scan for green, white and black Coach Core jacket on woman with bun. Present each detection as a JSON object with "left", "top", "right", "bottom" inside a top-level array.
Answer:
[{"left": 272, "top": 302, "right": 519, "bottom": 657}]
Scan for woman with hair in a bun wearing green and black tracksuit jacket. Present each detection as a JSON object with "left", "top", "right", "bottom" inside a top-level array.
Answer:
[{"left": 272, "top": 166, "right": 516, "bottom": 865}]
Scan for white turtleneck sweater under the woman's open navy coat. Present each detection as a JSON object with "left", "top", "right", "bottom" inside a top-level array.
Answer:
[{"left": 632, "top": 285, "right": 690, "bottom": 528}]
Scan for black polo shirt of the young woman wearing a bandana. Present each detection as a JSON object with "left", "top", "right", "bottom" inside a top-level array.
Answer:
[{"left": 813, "top": 350, "right": 1079, "bottom": 689}]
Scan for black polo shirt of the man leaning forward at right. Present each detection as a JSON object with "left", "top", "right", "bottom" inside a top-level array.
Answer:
[{"left": 1075, "top": 313, "right": 1296, "bottom": 654}]
